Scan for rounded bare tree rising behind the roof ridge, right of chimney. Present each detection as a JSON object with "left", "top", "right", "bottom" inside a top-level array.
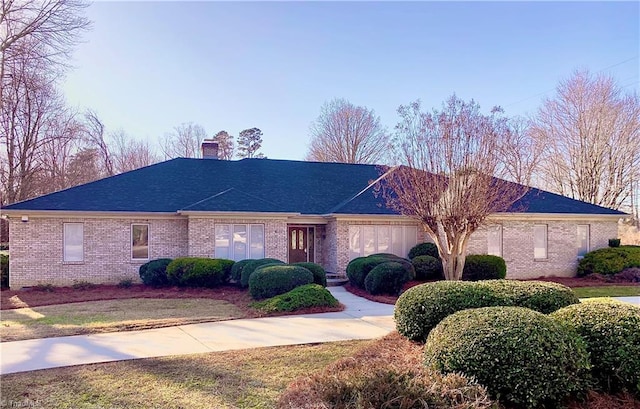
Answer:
[{"left": 307, "top": 99, "right": 390, "bottom": 164}]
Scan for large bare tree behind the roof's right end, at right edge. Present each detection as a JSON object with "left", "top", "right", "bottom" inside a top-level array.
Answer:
[{"left": 532, "top": 71, "right": 640, "bottom": 209}]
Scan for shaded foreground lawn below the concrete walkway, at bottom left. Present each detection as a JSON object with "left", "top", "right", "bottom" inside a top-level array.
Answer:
[{"left": 0, "top": 341, "right": 372, "bottom": 409}]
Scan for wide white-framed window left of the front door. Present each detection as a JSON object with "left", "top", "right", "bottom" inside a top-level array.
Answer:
[{"left": 215, "top": 224, "right": 264, "bottom": 261}]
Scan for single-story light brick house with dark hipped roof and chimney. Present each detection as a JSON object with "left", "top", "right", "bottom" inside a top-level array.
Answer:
[{"left": 1, "top": 145, "right": 624, "bottom": 288}]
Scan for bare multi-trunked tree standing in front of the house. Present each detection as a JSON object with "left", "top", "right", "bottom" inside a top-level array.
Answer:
[{"left": 381, "top": 95, "right": 528, "bottom": 280}]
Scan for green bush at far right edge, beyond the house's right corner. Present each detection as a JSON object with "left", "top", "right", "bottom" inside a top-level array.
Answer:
[{"left": 578, "top": 246, "right": 640, "bottom": 277}]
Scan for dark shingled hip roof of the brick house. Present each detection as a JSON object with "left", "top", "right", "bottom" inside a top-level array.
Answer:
[{"left": 5, "top": 158, "right": 624, "bottom": 215}]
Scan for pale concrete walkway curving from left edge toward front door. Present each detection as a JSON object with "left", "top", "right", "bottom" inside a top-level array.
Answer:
[{"left": 0, "top": 287, "right": 395, "bottom": 375}]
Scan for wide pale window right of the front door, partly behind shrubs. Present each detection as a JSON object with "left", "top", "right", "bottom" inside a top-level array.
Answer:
[{"left": 349, "top": 225, "right": 418, "bottom": 260}]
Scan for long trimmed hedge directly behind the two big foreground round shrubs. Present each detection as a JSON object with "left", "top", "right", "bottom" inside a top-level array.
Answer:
[{"left": 394, "top": 280, "right": 579, "bottom": 342}]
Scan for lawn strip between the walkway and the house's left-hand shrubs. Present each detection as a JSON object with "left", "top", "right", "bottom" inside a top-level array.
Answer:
[{"left": 0, "top": 298, "right": 245, "bottom": 342}]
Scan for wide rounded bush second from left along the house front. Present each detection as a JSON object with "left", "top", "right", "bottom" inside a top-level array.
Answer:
[{"left": 167, "top": 257, "right": 234, "bottom": 288}]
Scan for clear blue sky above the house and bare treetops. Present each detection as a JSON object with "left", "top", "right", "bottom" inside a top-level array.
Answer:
[{"left": 63, "top": 2, "right": 640, "bottom": 159}]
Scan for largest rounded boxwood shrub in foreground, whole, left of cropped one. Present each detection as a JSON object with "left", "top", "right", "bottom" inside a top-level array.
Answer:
[{"left": 424, "top": 307, "right": 589, "bottom": 408}]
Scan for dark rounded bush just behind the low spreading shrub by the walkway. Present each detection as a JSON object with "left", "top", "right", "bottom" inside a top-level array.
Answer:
[{"left": 245, "top": 264, "right": 313, "bottom": 300}]
